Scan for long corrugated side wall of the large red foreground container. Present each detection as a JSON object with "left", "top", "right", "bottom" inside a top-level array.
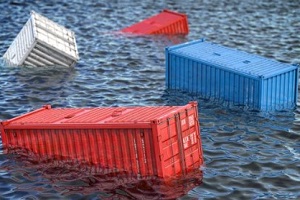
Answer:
[{"left": 4, "top": 128, "right": 160, "bottom": 176}]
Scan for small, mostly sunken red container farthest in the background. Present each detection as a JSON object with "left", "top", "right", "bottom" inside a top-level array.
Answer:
[{"left": 121, "top": 10, "right": 189, "bottom": 34}]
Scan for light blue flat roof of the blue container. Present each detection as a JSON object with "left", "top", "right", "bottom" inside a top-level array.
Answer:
[{"left": 169, "top": 39, "right": 297, "bottom": 78}]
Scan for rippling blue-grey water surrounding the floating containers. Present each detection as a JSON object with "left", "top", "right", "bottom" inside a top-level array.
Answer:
[{"left": 0, "top": 0, "right": 300, "bottom": 199}]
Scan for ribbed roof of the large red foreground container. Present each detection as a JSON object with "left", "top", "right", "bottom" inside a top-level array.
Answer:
[{"left": 5, "top": 104, "right": 190, "bottom": 125}]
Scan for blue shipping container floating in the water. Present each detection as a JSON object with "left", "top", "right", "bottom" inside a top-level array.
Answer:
[{"left": 165, "top": 39, "right": 298, "bottom": 110}]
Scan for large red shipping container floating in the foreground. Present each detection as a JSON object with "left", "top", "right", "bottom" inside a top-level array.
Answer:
[{"left": 0, "top": 102, "right": 204, "bottom": 178}]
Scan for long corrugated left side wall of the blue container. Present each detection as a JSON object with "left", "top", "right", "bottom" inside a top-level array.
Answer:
[{"left": 166, "top": 52, "right": 261, "bottom": 109}]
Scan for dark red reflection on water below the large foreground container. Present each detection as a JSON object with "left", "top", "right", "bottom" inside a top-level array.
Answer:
[{"left": 0, "top": 149, "right": 203, "bottom": 199}]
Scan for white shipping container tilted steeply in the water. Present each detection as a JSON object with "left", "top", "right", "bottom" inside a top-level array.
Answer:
[{"left": 3, "top": 11, "right": 79, "bottom": 67}]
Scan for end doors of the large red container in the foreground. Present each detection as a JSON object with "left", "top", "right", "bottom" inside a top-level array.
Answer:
[{"left": 152, "top": 104, "right": 204, "bottom": 177}]
